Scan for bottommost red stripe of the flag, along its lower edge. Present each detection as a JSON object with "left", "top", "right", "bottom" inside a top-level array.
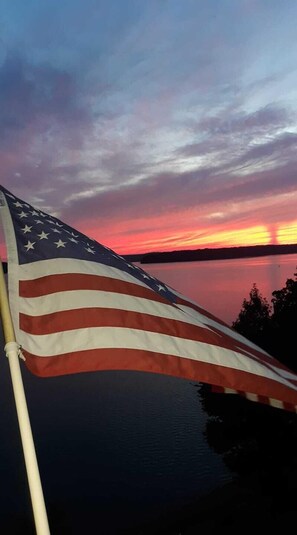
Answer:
[{"left": 24, "top": 348, "right": 297, "bottom": 410}]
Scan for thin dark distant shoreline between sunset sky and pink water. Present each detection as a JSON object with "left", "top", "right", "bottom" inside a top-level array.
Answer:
[{"left": 123, "top": 243, "right": 297, "bottom": 264}]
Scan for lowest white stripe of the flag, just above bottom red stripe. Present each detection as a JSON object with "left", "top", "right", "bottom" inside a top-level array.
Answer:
[{"left": 15, "top": 327, "right": 297, "bottom": 391}]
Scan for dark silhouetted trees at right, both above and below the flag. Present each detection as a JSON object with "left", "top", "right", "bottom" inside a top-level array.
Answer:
[{"left": 198, "top": 273, "right": 297, "bottom": 518}]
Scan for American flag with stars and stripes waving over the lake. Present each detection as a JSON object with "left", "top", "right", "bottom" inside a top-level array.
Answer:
[{"left": 0, "top": 187, "right": 297, "bottom": 411}]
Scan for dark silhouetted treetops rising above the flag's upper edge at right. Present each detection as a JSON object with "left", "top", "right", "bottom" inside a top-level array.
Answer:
[{"left": 232, "top": 273, "right": 297, "bottom": 372}]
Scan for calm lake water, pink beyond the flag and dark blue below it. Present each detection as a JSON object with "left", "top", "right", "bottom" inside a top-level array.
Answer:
[{"left": 0, "top": 255, "right": 297, "bottom": 535}]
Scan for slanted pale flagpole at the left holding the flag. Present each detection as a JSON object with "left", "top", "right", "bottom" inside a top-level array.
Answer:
[{"left": 0, "top": 259, "right": 50, "bottom": 535}]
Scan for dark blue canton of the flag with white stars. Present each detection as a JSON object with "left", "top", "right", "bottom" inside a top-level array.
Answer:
[{"left": 1, "top": 188, "right": 176, "bottom": 303}]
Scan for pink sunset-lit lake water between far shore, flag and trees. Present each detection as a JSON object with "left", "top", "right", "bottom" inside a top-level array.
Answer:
[{"left": 137, "top": 254, "right": 297, "bottom": 325}]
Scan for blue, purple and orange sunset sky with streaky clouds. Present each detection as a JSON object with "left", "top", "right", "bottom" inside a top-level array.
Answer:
[{"left": 0, "top": 0, "right": 297, "bottom": 254}]
